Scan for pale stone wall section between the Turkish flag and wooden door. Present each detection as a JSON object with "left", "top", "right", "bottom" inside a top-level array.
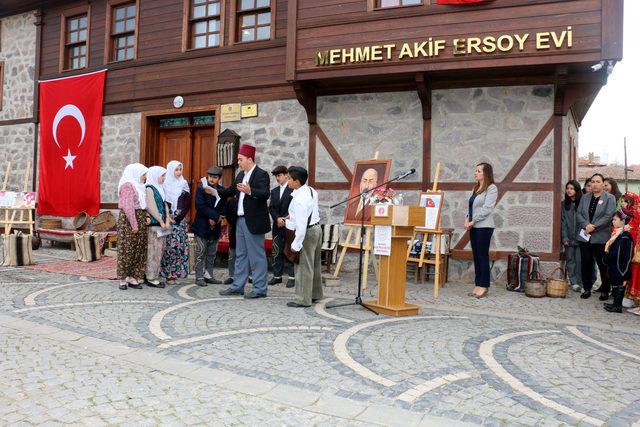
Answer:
[{"left": 100, "top": 113, "right": 141, "bottom": 203}]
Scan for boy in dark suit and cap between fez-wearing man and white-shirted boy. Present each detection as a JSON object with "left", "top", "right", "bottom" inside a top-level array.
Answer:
[{"left": 268, "top": 165, "right": 295, "bottom": 288}]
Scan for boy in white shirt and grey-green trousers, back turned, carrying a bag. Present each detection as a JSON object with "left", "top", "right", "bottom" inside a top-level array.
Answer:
[{"left": 285, "top": 166, "right": 322, "bottom": 307}]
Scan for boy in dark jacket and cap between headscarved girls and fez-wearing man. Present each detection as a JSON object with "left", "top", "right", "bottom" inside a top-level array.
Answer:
[{"left": 191, "top": 167, "right": 226, "bottom": 286}]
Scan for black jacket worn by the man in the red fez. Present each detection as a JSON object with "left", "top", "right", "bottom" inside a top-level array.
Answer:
[{"left": 220, "top": 166, "right": 271, "bottom": 234}]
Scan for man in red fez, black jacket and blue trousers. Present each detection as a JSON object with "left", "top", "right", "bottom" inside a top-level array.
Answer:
[{"left": 220, "top": 144, "right": 271, "bottom": 298}]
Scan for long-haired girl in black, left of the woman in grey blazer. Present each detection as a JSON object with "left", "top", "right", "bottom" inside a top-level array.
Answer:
[{"left": 561, "top": 180, "right": 582, "bottom": 292}]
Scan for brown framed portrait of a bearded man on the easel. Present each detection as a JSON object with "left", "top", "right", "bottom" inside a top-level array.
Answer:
[{"left": 344, "top": 160, "right": 391, "bottom": 224}]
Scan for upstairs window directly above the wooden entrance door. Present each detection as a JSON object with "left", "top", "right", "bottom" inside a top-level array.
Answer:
[{"left": 189, "top": 0, "right": 222, "bottom": 49}]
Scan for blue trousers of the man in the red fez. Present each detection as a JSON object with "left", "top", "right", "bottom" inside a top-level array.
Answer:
[{"left": 231, "top": 217, "right": 267, "bottom": 295}]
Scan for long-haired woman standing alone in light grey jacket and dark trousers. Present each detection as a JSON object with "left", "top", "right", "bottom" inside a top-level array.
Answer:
[{"left": 464, "top": 162, "right": 498, "bottom": 298}]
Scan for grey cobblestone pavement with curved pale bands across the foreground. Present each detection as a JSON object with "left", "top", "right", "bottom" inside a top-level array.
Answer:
[{"left": 0, "top": 248, "right": 640, "bottom": 426}]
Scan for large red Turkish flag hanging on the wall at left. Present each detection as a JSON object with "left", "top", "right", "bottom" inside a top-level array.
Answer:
[{"left": 38, "top": 70, "right": 106, "bottom": 216}]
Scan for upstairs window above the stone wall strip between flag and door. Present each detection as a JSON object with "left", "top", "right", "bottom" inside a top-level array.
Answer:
[{"left": 107, "top": 2, "right": 138, "bottom": 61}]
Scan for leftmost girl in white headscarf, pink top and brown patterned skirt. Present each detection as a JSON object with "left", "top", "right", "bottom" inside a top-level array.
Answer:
[{"left": 117, "top": 163, "right": 147, "bottom": 291}]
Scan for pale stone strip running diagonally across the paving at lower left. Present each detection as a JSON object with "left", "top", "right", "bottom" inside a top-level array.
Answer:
[{"left": 0, "top": 314, "right": 473, "bottom": 426}]
